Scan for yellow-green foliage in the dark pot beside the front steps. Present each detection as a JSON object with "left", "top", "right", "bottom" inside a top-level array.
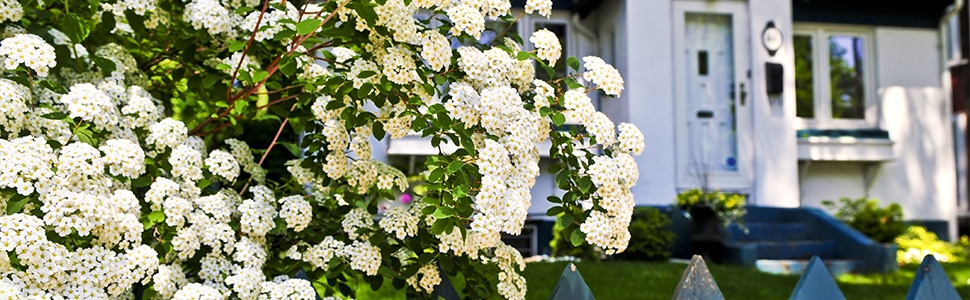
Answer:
[{"left": 677, "top": 189, "right": 747, "bottom": 225}]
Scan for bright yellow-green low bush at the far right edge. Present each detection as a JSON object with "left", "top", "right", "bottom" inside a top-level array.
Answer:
[{"left": 895, "top": 225, "right": 967, "bottom": 264}]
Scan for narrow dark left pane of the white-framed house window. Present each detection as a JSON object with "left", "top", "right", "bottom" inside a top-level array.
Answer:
[{"left": 794, "top": 35, "right": 815, "bottom": 118}]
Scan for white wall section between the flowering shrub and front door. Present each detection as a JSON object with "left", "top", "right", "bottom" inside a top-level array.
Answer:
[{"left": 612, "top": 0, "right": 677, "bottom": 205}]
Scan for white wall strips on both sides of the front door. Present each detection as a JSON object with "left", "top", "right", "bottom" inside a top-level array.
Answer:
[{"left": 597, "top": 0, "right": 799, "bottom": 207}]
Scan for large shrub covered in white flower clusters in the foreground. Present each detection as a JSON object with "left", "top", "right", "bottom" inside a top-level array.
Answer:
[{"left": 0, "top": 0, "right": 644, "bottom": 299}]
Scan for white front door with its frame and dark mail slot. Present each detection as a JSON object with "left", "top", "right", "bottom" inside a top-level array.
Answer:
[{"left": 674, "top": 1, "right": 753, "bottom": 192}]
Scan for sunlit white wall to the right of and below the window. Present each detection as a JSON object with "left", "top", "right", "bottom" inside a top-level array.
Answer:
[{"left": 802, "top": 27, "right": 956, "bottom": 238}]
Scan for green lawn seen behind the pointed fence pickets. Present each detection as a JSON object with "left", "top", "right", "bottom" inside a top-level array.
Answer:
[{"left": 524, "top": 261, "right": 970, "bottom": 300}]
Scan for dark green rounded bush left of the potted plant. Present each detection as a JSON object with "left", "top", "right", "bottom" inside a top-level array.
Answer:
[{"left": 618, "top": 207, "right": 674, "bottom": 260}]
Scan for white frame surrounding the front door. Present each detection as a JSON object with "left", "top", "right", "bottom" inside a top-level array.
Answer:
[{"left": 672, "top": 1, "right": 754, "bottom": 193}]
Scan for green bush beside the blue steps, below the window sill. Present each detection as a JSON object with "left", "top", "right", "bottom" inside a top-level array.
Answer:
[{"left": 822, "top": 197, "right": 906, "bottom": 243}]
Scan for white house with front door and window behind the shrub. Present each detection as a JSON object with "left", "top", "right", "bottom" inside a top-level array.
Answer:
[{"left": 386, "top": 0, "right": 962, "bottom": 246}]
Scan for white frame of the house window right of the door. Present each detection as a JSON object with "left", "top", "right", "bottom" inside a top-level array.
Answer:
[{"left": 793, "top": 24, "right": 879, "bottom": 129}]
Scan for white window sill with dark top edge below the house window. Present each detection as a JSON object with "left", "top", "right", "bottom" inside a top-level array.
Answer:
[{"left": 798, "top": 129, "right": 896, "bottom": 162}]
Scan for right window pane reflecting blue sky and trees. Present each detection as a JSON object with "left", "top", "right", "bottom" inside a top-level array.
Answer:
[{"left": 829, "top": 35, "right": 866, "bottom": 119}]
